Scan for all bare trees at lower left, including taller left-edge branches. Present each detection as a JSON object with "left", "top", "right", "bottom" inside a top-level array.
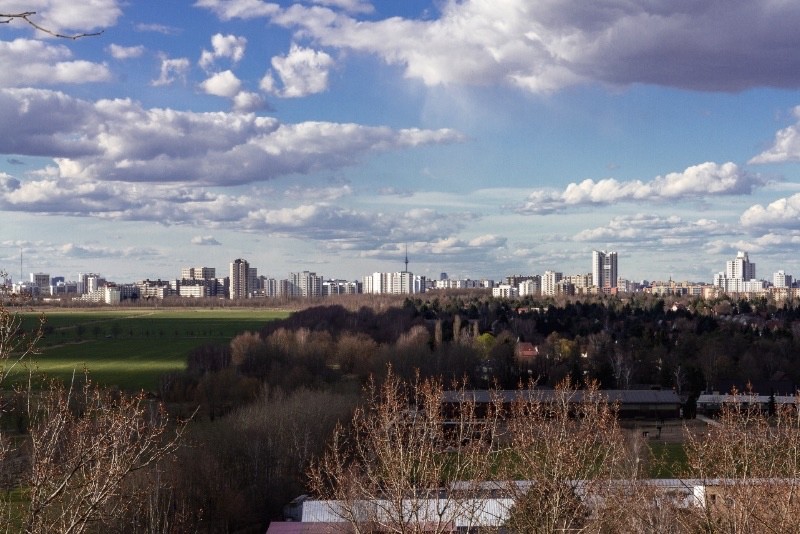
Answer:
[{"left": 0, "top": 305, "right": 184, "bottom": 533}]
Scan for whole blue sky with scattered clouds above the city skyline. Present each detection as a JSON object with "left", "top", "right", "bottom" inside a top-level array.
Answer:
[{"left": 0, "top": 0, "right": 800, "bottom": 282}]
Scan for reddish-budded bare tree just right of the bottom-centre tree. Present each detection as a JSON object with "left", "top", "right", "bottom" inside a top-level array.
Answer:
[{"left": 502, "top": 380, "right": 631, "bottom": 533}]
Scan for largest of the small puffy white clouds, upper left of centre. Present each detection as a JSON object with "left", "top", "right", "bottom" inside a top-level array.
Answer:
[{"left": 261, "top": 44, "right": 334, "bottom": 98}]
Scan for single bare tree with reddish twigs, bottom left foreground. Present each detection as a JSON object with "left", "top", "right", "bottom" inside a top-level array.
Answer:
[{"left": 23, "top": 380, "right": 182, "bottom": 533}]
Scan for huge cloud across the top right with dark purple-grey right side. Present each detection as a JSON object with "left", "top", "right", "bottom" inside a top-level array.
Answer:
[{"left": 195, "top": 0, "right": 800, "bottom": 92}]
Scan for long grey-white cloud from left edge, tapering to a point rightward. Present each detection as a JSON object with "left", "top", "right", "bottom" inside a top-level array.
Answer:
[{"left": 0, "top": 89, "right": 463, "bottom": 185}]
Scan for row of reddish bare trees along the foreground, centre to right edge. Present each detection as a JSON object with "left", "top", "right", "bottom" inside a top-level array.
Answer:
[{"left": 310, "top": 375, "right": 800, "bottom": 534}]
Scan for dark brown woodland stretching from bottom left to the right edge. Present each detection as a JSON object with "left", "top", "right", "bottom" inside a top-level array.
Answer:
[{"left": 4, "top": 292, "right": 800, "bottom": 532}]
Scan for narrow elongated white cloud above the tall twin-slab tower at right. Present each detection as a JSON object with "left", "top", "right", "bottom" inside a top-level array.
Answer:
[{"left": 516, "top": 162, "right": 765, "bottom": 214}]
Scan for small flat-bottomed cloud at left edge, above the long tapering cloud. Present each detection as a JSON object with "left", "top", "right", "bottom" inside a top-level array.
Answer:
[{"left": 0, "top": 39, "right": 111, "bottom": 87}]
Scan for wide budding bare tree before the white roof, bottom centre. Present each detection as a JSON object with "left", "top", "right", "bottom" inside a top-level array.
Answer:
[{"left": 310, "top": 371, "right": 497, "bottom": 533}]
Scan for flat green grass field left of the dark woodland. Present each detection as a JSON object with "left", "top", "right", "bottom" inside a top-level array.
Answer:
[{"left": 7, "top": 308, "right": 289, "bottom": 390}]
